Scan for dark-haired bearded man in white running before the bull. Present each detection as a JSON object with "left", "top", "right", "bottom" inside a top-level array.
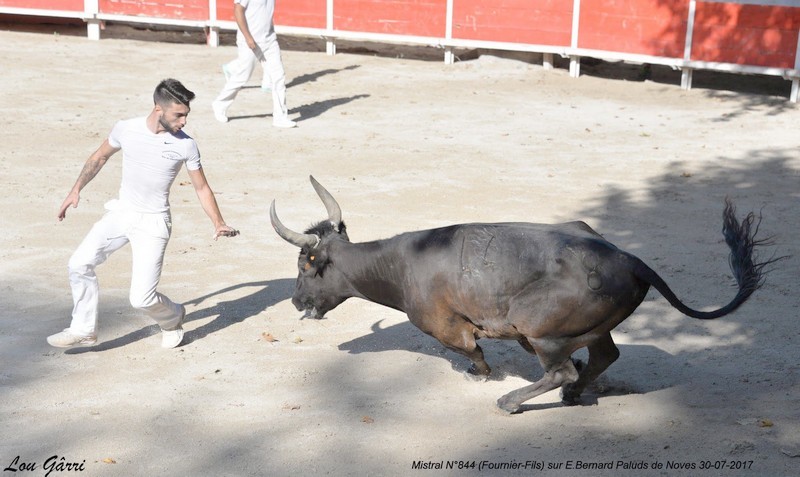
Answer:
[{"left": 47, "top": 79, "right": 238, "bottom": 348}]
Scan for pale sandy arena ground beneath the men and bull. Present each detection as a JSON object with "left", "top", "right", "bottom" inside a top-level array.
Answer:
[{"left": 0, "top": 21, "right": 800, "bottom": 477}]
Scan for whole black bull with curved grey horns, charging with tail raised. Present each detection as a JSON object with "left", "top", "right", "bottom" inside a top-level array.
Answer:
[{"left": 270, "top": 177, "right": 772, "bottom": 412}]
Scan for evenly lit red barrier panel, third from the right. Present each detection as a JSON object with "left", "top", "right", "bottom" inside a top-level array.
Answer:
[{"left": 453, "top": 0, "right": 573, "bottom": 46}]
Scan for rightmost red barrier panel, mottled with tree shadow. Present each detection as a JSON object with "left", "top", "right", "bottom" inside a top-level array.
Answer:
[{"left": 691, "top": 3, "right": 800, "bottom": 69}]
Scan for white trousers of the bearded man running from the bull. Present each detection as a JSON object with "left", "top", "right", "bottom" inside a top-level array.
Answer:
[{"left": 68, "top": 200, "right": 183, "bottom": 336}]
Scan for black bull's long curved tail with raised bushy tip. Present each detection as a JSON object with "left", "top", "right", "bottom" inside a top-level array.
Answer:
[{"left": 634, "top": 198, "right": 787, "bottom": 320}]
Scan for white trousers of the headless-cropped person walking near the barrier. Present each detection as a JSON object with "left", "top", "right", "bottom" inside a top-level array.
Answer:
[{"left": 215, "top": 35, "right": 289, "bottom": 119}]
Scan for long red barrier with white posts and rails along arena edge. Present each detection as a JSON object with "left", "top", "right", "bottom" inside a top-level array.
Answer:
[{"left": 0, "top": 0, "right": 800, "bottom": 102}]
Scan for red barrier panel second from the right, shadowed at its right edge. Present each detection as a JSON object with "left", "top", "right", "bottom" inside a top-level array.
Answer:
[{"left": 578, "top": 0, "right": 689, "bottom": 58}]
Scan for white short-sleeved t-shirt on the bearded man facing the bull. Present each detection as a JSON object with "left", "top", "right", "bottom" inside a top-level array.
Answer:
[{"left": 108, "top": 117, "right": 202, "bottom": 213}]
